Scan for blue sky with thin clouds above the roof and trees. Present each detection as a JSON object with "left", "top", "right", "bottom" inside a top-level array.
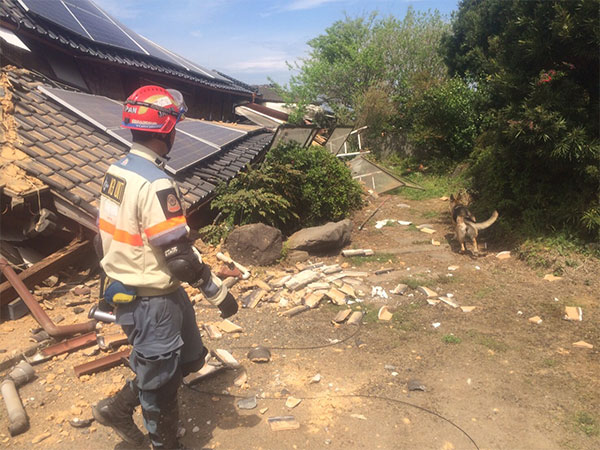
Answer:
[{"left": 95, "top": 0, "right": 458, "bottom": 84}]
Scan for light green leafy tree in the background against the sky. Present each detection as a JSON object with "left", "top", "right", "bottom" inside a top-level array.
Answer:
[{"left": 280, "top": 8, "right": 449, "bottom": 155}]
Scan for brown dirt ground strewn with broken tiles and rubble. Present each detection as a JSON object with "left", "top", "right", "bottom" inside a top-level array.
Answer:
[{"left": 0, "top": 195, "right": 600, "bottom": 450}]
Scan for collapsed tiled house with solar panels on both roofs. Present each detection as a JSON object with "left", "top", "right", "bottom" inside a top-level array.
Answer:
[{"left": 0, "top": 0, "right": 273, "bottom": 306}]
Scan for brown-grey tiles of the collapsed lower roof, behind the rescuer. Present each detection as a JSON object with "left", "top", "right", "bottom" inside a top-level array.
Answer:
[{"left": 2, "top": 68, "right": 273, "bottom": 221}]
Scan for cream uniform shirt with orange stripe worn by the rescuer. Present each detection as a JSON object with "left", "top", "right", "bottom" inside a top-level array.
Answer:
[{"left": 98, "top": 143, "right": 189, "bottom": 296}]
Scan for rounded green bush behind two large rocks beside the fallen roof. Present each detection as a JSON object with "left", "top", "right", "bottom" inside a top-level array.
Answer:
[{"left": 200, "top": 144, "right": 362, "bottom": 243}]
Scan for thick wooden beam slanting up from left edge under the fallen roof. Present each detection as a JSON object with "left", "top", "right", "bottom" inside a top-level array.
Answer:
[{"left": 0, "top": 241, "right": 92, "bottom": 306}]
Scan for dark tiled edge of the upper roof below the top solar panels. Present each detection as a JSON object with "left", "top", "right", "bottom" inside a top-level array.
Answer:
[{"left": 0, "top": 0, "right": 253, "bottom": 95}]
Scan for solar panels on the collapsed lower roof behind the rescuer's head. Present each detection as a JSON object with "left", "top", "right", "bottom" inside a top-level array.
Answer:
[{"left": 39, "top": 86, "right": 247, "bottom": 174}]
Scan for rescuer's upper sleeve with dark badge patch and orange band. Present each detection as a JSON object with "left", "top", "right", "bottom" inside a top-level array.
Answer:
[{"left": 139, "top": 178, "right": 189, "bottom": 247}]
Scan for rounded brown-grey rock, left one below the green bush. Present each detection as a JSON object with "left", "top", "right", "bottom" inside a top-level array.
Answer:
[{"left": 225, "top": 223, "right": 282, "bottom": 266}]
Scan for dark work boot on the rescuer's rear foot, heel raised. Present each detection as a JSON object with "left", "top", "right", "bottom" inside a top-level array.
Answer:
[{"left": 92, "top": 382, "right": 145, "bottom": 446}]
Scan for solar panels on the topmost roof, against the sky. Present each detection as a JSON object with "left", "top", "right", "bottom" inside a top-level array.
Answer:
[{"left": 19, "top": 0, "right": 229, "bottom": 82}]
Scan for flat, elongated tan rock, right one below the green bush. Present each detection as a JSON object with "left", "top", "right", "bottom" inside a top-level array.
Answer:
[{"left": 287, "top": 219, "right": 352, "bottom": 254}]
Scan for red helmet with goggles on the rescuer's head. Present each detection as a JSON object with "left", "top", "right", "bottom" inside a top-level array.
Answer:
[{"left": 121, "top": 86, "right": 187, "bottom": 134}]
